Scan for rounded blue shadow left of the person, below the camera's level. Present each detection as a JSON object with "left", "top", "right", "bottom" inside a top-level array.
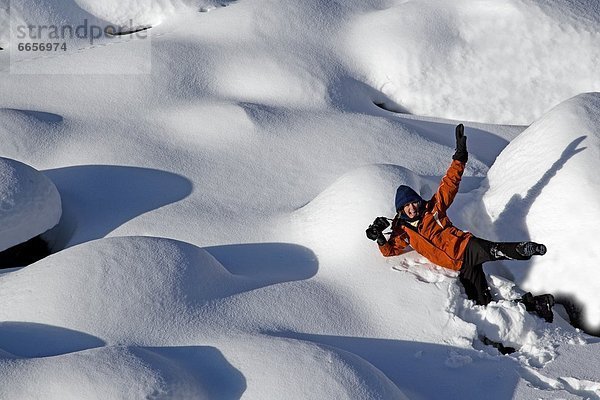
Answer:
[{"left": 204, "top": 243, "right": 319, "bottom": 286}]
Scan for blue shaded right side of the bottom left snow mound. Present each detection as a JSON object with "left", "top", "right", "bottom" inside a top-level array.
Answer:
[{"left": 132, "top": 346, "right": 247, "bottom": 400}]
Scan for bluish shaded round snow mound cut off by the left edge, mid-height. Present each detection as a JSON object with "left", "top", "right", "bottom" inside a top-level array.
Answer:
[{"left": 0, "top": 157, "right": 62, "bottom": 251}]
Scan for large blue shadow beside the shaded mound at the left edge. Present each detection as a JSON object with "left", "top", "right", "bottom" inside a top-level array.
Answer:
[{"left": 44, "top": 165, "right": 193, "bottom": 251}]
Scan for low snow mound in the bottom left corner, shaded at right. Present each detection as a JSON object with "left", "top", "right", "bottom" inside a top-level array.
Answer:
[{"left": 0, "top": 346, "right": 245, "bottom": 399}]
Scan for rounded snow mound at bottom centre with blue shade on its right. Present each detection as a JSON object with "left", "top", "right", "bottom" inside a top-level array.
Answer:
[{"left": 224, "top": 336, "right": 407, "bottom": 400}]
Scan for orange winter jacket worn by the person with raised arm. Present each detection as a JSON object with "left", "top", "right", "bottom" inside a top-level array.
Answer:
[{"left": 379, "top": 160, "right": 473, "bottom": 271}]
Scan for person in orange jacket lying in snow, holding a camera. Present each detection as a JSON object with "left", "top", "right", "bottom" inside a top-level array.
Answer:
[{"left": 366, "top": 124, "right": 554, "bottom": 322}]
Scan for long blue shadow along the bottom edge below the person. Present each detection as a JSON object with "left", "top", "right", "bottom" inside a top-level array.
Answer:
[{"left": 265, "top": 332, "right": 521, "bottom": 400}]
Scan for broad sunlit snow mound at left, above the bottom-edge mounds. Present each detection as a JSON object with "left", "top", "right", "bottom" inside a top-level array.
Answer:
[{"left": 0, "top": 237, "right": 245, "bottom": 342}]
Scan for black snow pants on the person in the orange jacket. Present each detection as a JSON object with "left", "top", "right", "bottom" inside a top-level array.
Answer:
[{"left": 458, "top": 237, "right": 531, "bottom": 306}]
